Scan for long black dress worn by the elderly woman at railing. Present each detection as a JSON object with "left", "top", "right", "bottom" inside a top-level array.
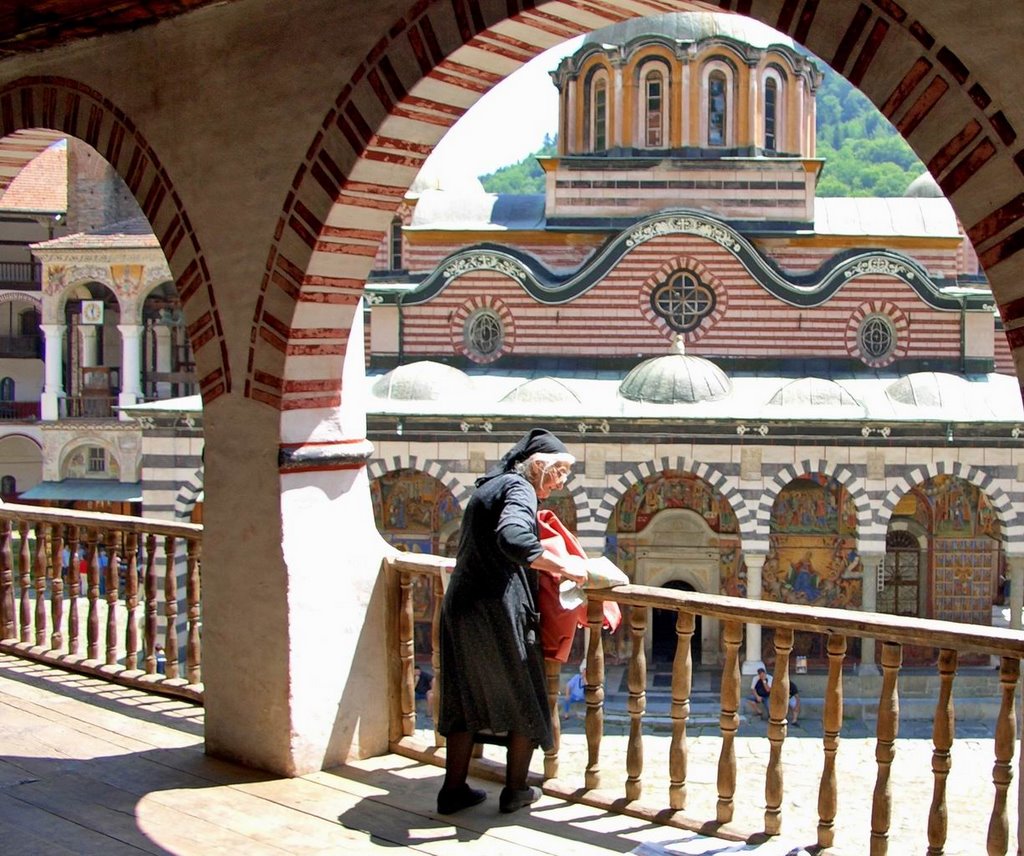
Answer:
[{"left": 437, "top": 473, "right": 553, "bottom": 748}]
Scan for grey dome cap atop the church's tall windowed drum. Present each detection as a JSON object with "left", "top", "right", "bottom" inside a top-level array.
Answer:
[{"left": 583, "top": 12, "right": 794, "bottom": 48}]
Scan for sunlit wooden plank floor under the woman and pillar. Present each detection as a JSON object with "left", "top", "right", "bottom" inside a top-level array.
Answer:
[{"left": 0, "top": 655, "right": 770, "bottom": 856}]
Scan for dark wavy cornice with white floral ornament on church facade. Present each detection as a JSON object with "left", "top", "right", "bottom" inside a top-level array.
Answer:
[{"left": 401, "top": 209, "right": 992, "bottom": 310}]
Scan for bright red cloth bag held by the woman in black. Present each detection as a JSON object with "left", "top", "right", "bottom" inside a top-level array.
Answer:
[{"left": 537, "top": 508, "right": 623, "bottom": 662}]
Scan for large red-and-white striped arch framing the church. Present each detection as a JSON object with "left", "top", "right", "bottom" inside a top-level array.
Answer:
[{"left": 258, "top": 0, "right": 1024, "bottom": 438}]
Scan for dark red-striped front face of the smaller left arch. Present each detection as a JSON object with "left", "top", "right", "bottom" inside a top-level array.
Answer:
[{"left": 0, "top": 77, "right": 231, "bottom": 403}]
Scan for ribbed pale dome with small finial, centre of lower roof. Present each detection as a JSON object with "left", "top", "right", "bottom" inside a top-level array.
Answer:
[{"left": 618, "top": 340, "right": 732, "bottom": 404}]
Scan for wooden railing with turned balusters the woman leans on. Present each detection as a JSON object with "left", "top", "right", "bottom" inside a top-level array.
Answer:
[{"left": 384, "top": 553, "right": 1024, "bottom": 856}]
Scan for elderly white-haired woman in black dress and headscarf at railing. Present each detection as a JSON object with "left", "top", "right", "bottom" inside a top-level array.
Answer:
[{"left": 437, "top": 428, "right": 587, "bottom": 814}]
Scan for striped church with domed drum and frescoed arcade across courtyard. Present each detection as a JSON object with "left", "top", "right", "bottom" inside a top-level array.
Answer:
[{"left": 364, "top": 14, "right": 1024, "bottom": 671}]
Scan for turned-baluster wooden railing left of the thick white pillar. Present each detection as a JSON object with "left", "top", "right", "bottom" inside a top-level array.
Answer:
[{"left": 0, "top": 504, "right": 203, "bottom": 701}]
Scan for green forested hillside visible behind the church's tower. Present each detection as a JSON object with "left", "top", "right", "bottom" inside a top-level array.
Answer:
[{"left": 480, "top": 62, "right": 925, "bottom": 197}]
